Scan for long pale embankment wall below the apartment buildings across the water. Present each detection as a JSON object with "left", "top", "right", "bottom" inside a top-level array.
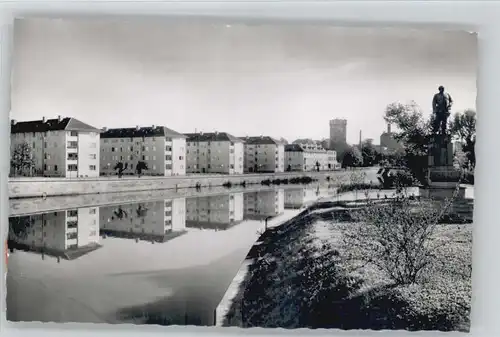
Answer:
[{"left": 8, "top": 168, "right": 376, "bottom": 199}]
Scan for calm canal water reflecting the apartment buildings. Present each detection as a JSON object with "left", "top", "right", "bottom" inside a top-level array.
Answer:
[{"left": 7, "top": 185, "right": 335, "bottom": 326}]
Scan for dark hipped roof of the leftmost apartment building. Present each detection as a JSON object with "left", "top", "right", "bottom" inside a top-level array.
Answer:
[{"left": 10, "top": 117, "right": 100, "bottom": 133}]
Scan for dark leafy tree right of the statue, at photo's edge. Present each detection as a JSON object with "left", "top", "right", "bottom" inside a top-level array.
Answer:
[{"left": 450, "top": 109, "right": 476, "bottom": 169}]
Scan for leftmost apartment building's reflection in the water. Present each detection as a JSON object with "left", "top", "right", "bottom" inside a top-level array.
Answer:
[{"left": 9, "top": 207, "right": 100, "bottom": 260}]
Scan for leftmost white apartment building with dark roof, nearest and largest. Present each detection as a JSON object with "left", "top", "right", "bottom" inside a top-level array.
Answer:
[{"left": 10, "top": 116, "right": 100, "bottom": 178}]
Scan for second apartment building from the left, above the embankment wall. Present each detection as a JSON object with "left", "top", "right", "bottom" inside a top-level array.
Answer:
[{"left": 101, "top": 125, "right": 186, "bottom": 176}]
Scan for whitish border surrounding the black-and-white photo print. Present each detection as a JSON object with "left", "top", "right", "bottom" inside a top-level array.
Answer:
[{"left": 0, "top": 0, "right": 500, "bottom": 337}]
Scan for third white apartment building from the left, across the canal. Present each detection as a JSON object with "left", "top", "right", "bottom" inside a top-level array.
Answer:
[{"left": 186, "top": 132, "right": 244, "bottom": 174}]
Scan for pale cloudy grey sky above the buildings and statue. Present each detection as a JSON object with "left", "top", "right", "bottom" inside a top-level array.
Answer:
[{"left": 11, "top": 19, "right": 477, "bottom": 144}]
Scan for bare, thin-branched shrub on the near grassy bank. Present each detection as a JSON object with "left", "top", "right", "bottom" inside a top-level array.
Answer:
[{"left": 341, "top": 184, "right": 459, "bottom": 285}]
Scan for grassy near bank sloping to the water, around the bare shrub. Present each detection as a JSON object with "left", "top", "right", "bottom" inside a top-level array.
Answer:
[{"left": 217, "top": 189, "right": 472, "bottom": 331}]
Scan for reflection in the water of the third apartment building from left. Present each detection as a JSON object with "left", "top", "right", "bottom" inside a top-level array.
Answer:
[{"left": 186, "top": 193, "right": 244, "bottom": 229}]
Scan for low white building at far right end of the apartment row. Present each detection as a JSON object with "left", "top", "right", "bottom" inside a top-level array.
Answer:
[{"left": 285, "top": 144, "right": 340, "bottom": 171}]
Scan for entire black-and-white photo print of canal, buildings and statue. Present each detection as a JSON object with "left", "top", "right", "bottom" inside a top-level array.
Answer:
[{"left": 5, "top": 17, "right": 478, "bottom": 332}]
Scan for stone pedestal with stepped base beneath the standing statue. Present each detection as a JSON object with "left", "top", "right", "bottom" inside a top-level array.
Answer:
[{"left": 420, "top": 135, "right": 465, "bottom": 200}]
